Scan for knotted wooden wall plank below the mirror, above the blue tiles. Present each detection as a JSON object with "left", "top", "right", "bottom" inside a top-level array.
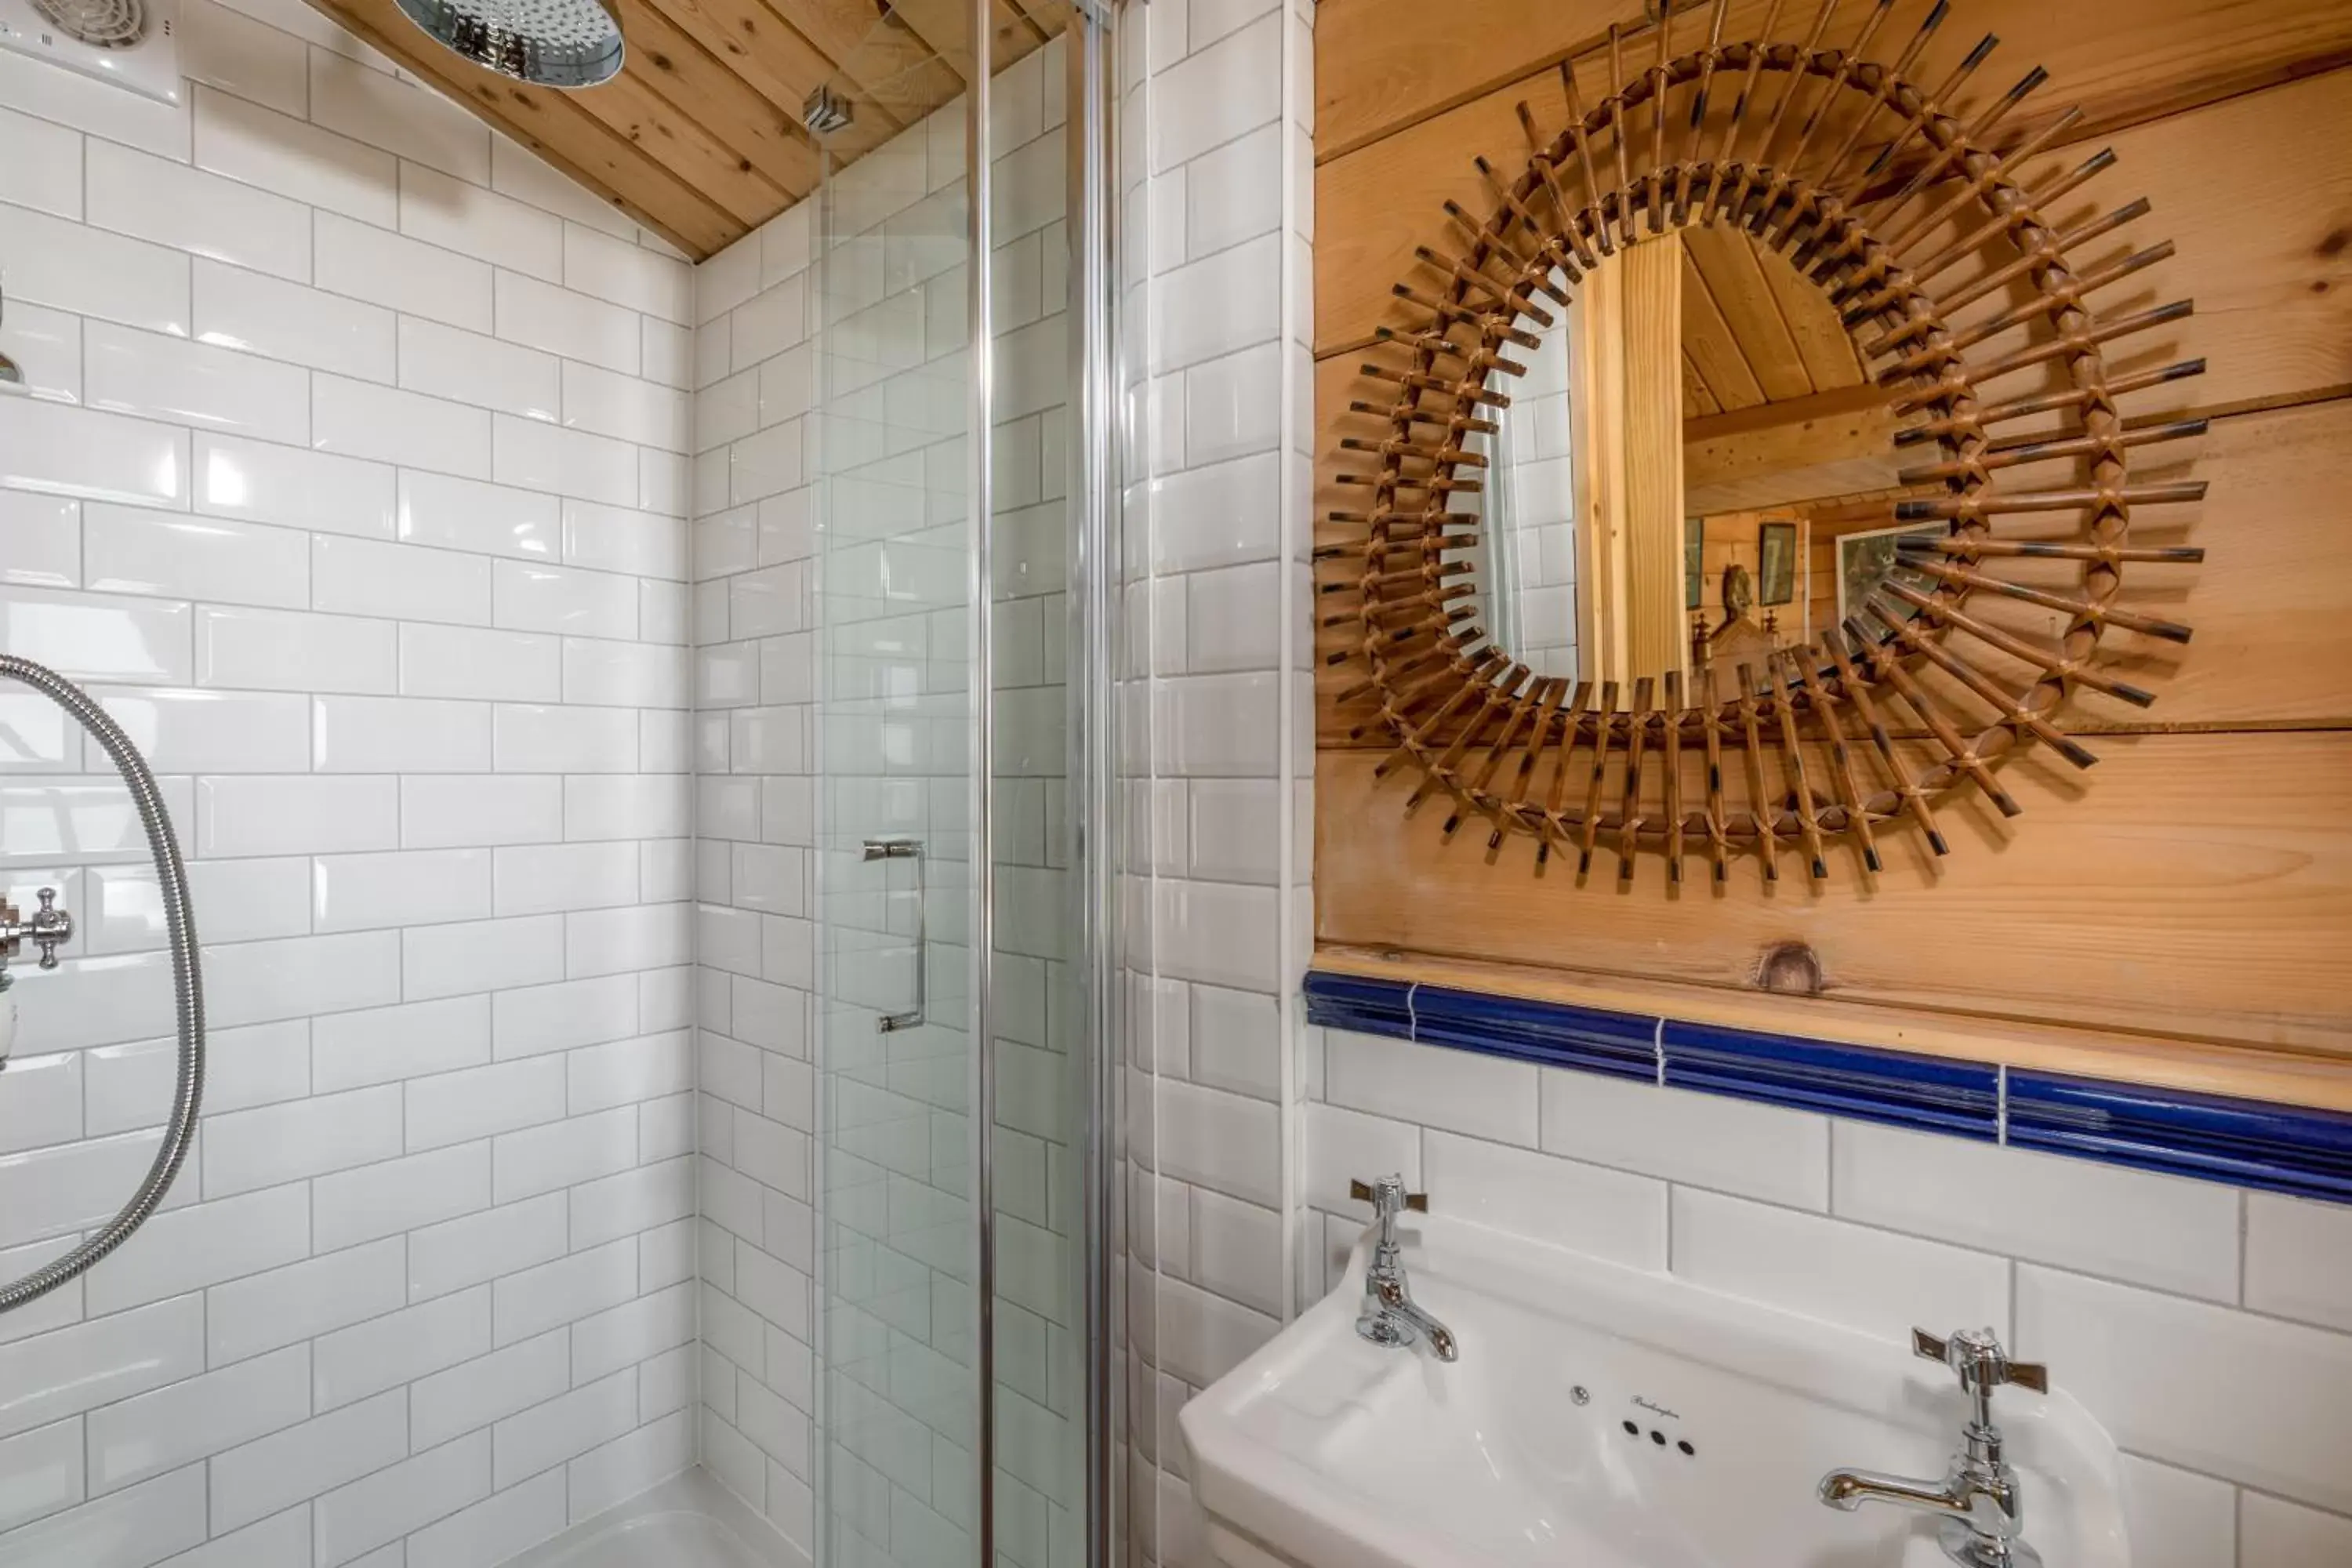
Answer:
[{"left": 1315, "top": 731, "right": 2352, "bottom": 1053}]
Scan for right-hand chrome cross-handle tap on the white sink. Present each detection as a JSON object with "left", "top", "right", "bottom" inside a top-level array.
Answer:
[{"left": 1820, "top": 1328, "right": 2051, "bottom": 1568}]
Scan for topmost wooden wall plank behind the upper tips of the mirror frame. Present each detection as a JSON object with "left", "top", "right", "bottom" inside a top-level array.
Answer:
[{"left": 1315, "top": 0, "right": 2352, "bottom": 162}]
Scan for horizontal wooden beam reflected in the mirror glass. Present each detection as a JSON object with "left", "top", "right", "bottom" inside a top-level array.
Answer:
[{"left": 1682, "top": 386, "right": 1896, "bottom": 515}]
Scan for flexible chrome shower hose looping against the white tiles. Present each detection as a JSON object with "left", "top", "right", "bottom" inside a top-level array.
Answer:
[{"left": 0, "top": 654, "right": 205, "bottom": 1312}]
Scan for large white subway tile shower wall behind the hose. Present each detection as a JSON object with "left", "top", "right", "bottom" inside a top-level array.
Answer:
[{"left": 0, "top": 15, "right": 696, "bottom": 1568}]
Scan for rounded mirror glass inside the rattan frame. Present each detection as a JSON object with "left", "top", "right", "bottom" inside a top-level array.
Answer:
[{"left": 1454, "top": 226, "right": 1945, "bottom": 701}]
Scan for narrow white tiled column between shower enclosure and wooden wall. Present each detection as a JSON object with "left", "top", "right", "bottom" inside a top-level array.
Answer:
[{"left": 1120, "top": 0, "right": 1327, "bottom": 1568}]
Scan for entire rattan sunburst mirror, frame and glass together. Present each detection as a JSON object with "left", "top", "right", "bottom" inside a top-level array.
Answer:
[{"left": 1317, "top": 0, "right": 2204, "bottom": 881}]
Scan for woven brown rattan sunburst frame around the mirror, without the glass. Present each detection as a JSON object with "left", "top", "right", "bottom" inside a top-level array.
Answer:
[{"left": 1315, "top": 0, "right": 2204, "bottom": 881}]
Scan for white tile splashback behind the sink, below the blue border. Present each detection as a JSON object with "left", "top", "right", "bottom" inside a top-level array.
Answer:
[{"left": 1305, "top": 1029, "right": 2352, "bottom": 1568}]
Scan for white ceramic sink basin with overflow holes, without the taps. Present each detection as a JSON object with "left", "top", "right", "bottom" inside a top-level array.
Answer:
[{"left": 1181, "top": 1215, "right": 2131, "bottom": 1568}]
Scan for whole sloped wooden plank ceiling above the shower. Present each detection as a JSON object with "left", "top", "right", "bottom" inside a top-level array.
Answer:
[{"left": 310, "top": 0, "right": 1063, "bottom": 261}]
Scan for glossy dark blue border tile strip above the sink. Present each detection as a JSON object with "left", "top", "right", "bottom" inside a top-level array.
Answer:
[{"left": 1305, "top": 973, "right": 2352, "bottom": 1203}]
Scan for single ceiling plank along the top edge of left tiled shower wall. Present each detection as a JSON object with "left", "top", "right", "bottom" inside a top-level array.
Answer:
[{"left": 310, "top": 0, "right": 746, "bottom": 256}]
